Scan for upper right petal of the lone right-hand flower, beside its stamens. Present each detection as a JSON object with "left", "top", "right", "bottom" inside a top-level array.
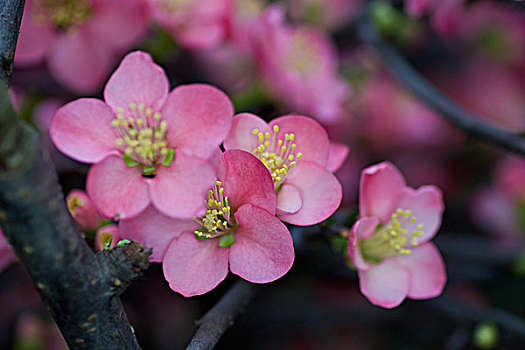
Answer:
[{"left": 398, "top": 186, "right": 445, "bottom": 244}]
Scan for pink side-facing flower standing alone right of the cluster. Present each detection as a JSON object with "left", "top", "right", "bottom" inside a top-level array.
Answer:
[{"left": 348, "top": 162, "right": 446, "bottom": 308}]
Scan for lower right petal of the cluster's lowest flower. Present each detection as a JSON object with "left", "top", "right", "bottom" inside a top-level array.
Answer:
[{"left": 230, "top": 204, "right": 295, "bottom": 283}]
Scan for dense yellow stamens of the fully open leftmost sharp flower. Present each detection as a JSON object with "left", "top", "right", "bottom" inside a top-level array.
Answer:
[{"left": 111, "top": 103, "right": 175, "bottom": 175}]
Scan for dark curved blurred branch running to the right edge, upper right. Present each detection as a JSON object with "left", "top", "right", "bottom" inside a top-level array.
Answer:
[{"left": 357, "top": 9, "right": 525, "bottom": 156}]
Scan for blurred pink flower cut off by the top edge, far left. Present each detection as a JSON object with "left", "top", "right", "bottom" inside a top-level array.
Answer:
[{"left": 15, "top": 0, "right": 147, "bottom": 92}]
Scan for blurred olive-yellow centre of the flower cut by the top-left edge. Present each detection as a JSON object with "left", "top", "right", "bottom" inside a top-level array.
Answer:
[{"left": 35, "top": 0, "right": 92, "bottom": 30}]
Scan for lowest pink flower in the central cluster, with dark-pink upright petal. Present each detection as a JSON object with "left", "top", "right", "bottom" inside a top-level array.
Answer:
[{"left": 119, "top": 150, "right": 294, "bottom": 297}]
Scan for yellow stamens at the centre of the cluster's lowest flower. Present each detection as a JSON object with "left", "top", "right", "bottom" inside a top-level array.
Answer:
[{"left": 193, "top": 181, "right": 237, "bottom": 248}]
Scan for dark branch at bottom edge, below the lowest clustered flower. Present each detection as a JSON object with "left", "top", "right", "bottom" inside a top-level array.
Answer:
[{"left": 186, "top": 280, "right": 260, "bottom": 350}]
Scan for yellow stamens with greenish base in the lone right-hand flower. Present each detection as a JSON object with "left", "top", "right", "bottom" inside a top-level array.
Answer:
[{"left": 360, "top": 209, "right": 423, "bottom": 263}]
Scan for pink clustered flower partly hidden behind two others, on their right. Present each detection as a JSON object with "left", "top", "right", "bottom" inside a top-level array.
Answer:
[{"left": 224, "top": 113, "right": 348, "bottom": 225}]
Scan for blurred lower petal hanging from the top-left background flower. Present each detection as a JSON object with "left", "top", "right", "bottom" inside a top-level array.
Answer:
[{"left": 48, "top": 28, "right": 113, "bottom": 93}]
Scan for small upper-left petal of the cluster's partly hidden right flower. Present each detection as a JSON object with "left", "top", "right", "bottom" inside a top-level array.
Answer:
[{"left": 224, "top": 113, "right": 270, "bottom": 152}]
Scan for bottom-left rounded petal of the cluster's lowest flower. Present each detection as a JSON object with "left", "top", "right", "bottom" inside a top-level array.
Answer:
[{"left": 162, "top": 232, "right": 230, "bottom": 297}]
